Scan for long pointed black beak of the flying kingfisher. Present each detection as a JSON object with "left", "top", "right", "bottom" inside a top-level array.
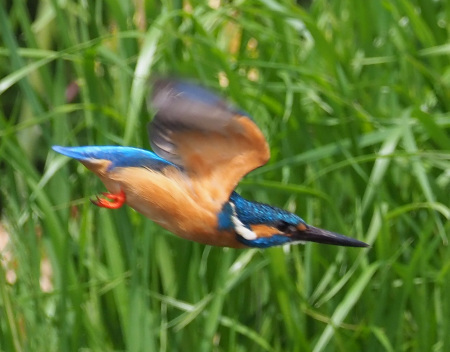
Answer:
[{"left": 292, "top": 225, "right": 369, "bottom": 247}]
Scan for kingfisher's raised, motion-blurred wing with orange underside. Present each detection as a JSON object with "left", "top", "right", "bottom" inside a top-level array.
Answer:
[{"left": 149, "top": 79, "right": 270, "bottom": 201}]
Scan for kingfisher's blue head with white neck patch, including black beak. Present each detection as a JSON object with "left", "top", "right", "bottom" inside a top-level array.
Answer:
[{"left": 219, "top": 192, "right": 367, "bottom": 248}]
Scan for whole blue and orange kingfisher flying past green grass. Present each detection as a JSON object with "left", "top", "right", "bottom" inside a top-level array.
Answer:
[{"left": 53, "top": 78, "right": 368, "bottom": 248}]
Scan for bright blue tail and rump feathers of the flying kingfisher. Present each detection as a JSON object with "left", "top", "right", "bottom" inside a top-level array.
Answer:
[{"left": 52, "top": 145, "right": 178, "bottom": 171}]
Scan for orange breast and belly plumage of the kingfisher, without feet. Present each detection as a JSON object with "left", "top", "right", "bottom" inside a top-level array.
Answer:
[{"left": 99, "top": 167, "right": 242, "bottom": 247}]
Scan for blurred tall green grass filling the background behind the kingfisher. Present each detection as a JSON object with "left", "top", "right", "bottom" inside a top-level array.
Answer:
[{"left": 0, "top": 0, "right": 450, "bottom": 352}]
